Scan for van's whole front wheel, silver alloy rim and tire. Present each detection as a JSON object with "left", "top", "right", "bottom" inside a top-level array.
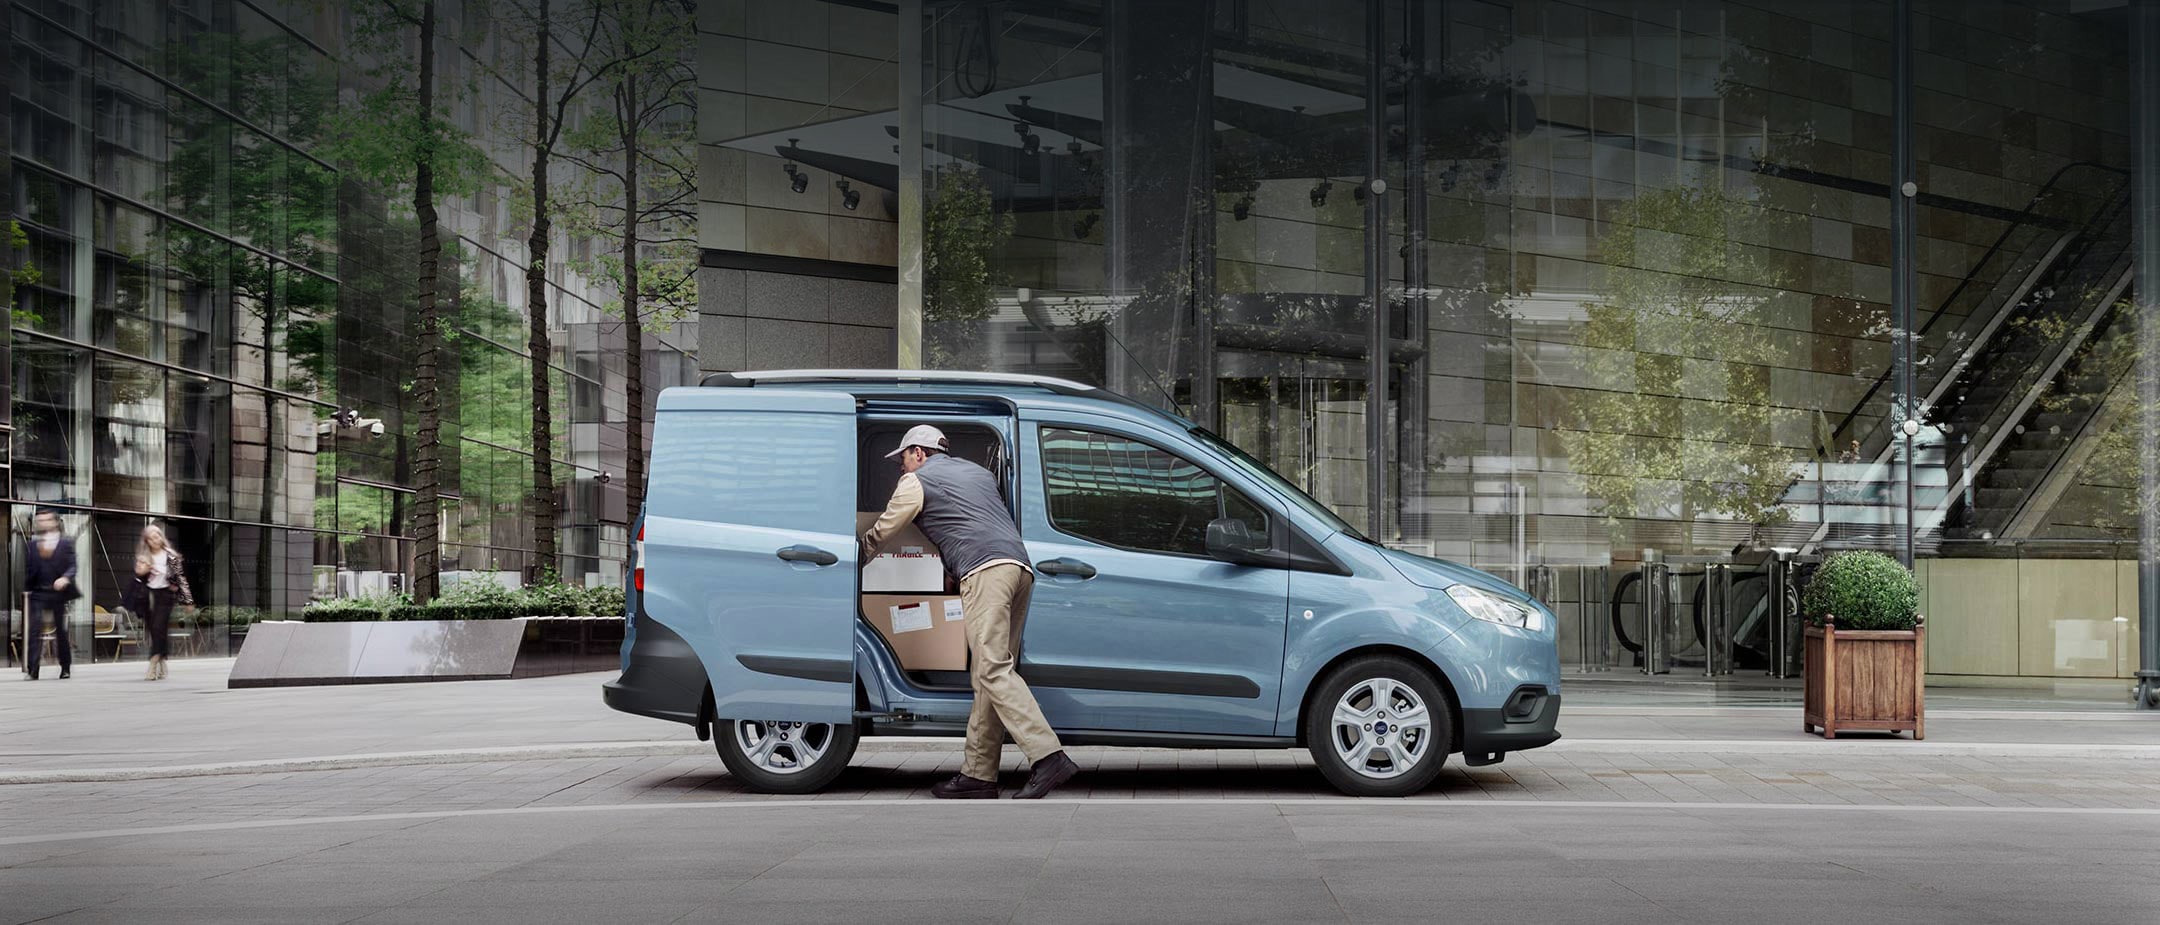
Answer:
[{"left": 1305, "top": 655, "right": 1454, "bottom": 797}]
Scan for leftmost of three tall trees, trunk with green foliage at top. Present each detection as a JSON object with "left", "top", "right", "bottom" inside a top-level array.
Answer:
[{"left": 326, "top": 0, "right": 488, "bottom": 603}]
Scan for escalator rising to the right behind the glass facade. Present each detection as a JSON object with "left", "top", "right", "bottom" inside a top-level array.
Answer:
[{"left": 1788, "top": 164, "right": 2132, "bottom": 553}]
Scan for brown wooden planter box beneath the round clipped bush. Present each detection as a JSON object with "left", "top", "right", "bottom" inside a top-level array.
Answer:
[{"left": 1801, "top": 618, "right": 1927, "bottom": 739}]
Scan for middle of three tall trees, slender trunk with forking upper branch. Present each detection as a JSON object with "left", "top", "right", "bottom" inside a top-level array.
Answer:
[{"left": 518, "top": 0, "right": 622, "bottom": 577}]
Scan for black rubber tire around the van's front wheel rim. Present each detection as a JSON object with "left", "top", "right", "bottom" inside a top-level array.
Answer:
[{"left": 1305, "top": 655, "right": 1456, "bottom": 797}]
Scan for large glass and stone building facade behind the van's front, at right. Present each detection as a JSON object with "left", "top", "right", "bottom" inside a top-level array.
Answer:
[{"left": 708, "top": 0, "right": 2160, "bottom": 691}]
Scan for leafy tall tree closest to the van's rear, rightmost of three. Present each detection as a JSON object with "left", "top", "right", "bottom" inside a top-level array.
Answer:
[{"left": 570, "top": 0, "right": 698, "bottom": 517}]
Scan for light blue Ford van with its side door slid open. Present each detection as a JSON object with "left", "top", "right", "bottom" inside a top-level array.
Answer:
[{"left": 605, "top": 370, "right": 1560, "bottom": 795}]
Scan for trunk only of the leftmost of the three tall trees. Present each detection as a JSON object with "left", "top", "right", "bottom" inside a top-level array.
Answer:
[{"left": 412, "top": 0, "right": 443, "bottom": 603}]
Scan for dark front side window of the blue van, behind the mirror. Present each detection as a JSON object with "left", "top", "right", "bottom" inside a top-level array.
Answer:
[{"left": 1041, "top": 426, "right": 1268, "bottom": 555}]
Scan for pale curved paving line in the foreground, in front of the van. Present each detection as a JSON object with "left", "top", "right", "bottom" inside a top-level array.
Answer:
[{"left": 0, "top": 797, "right": 2160, "bottom": 847}]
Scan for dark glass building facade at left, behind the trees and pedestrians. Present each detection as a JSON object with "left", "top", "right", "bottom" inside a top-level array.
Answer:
[{"left": 0, "top": 0, "right": 689, "bottom": 659}]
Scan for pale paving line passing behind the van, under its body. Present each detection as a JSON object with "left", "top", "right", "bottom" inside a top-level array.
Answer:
[{"left": 0, "top": 735, "right": 2160, "bottom": 787}]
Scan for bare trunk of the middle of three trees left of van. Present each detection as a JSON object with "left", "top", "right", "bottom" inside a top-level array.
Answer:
[{"left": 525, "top": 0, "right": 557, "bottom": 579}]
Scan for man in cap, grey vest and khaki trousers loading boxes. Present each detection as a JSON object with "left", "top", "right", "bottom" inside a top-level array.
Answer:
[{"left": 862, "top": 424, "right": 1080, "bottom": 800}]
